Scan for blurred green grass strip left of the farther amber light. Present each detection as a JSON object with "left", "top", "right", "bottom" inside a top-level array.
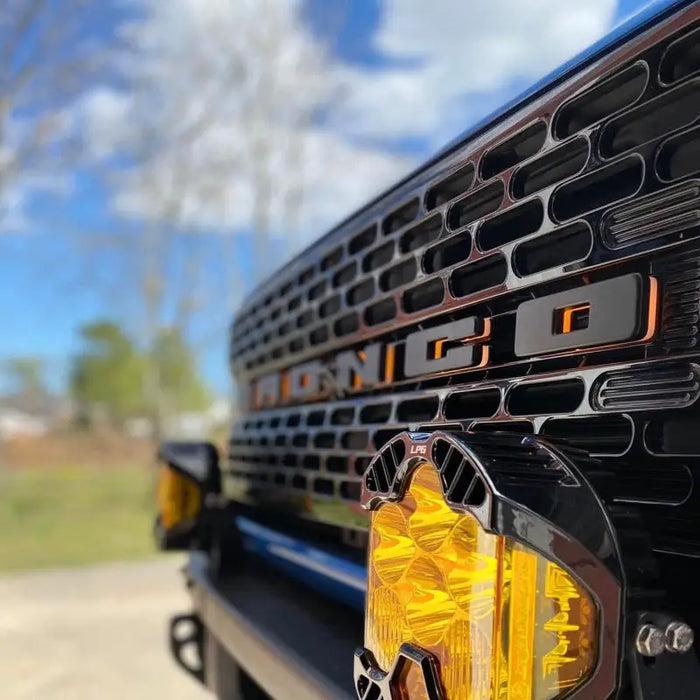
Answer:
[{"left": 0, "top": 466, "right": 156, "bottom": 571}]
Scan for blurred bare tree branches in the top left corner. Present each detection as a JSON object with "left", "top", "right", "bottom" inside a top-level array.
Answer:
[{"left": 0, "top": 0, "right": 110, "bottom": 226}]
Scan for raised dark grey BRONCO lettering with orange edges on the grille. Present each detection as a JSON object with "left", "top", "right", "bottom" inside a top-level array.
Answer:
[{"left": 250, "top": 274, "right": 657, "bottom": 410}]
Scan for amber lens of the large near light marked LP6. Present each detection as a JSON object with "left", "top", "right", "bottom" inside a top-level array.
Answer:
[{"left": 365, "top": 463, "right": 598, "bottom": 700}]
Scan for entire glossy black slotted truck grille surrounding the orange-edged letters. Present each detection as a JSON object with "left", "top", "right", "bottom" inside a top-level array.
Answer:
[{"left": 227, "top": 6, "right": 700, "bottom": 555}]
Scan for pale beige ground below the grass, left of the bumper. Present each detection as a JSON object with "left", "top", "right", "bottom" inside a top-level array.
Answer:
[{"left": 0, "top": 558, "right": 212, "bottom": 700}]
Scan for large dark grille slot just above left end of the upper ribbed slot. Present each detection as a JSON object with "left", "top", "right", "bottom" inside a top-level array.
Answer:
[{"left": 552, "top": 156, "right": 644, "bottom": 221}]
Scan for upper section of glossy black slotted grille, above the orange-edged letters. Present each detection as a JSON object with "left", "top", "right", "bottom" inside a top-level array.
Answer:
[{"left": 232, "top": 16, "right": 700, "bottom": 377}]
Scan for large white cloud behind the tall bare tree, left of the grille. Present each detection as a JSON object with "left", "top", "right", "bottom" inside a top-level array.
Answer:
[{"left": 76, "top": 0, "right": 409, "bottom": 260}]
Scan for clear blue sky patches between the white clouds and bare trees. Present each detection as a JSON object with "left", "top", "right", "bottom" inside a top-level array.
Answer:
[{"left": 0, "top": 0, "right": 660, "bottom": 393}]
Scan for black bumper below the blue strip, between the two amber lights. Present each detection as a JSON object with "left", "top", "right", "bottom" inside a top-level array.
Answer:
[{"left": 179, "top": 553, "right": 363, "bottom": 700}]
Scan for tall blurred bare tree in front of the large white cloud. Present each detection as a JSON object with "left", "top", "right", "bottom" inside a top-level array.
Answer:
[{"left": 78, "top": 0, "right": 331, "bottom": 434}]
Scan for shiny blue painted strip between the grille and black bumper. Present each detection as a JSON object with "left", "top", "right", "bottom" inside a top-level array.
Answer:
[{"left": 236, "top": 516, "right": 367, "bottom": 610}]
